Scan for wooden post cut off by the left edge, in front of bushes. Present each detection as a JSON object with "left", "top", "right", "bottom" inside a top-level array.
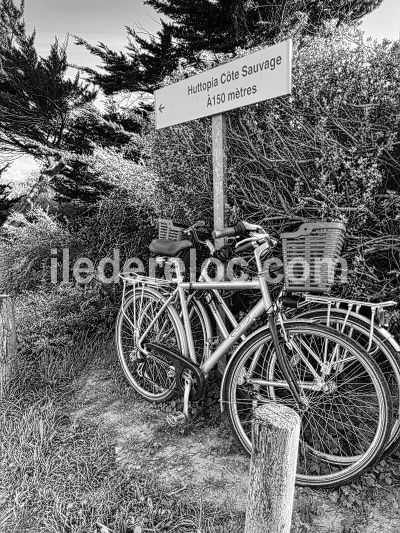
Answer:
[{"left": 0, "top": 294, "right": 17, "bottom": 399}]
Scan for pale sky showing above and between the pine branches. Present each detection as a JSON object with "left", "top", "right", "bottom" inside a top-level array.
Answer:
[{"left": 2, "top": 0, "right": 400, "bottom": 181}]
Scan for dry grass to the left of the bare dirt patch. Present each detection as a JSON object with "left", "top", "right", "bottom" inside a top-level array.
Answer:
[{"left": 0, "top": 332, "right": 243, "bottom": 533}]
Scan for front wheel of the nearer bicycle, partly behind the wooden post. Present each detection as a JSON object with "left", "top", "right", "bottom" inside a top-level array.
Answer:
[{"left": 224, "top": 322, "right": 391, "bottom": 488}]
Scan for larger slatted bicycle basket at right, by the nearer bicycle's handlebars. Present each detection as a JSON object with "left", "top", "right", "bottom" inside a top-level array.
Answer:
[{"left": 281, "top": 222, "right": 346, "bottom": 293}]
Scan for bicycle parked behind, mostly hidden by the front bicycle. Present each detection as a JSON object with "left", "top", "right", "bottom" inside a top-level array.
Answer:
[{"left": 158, "top": 220, "right": 400, "bottom": 458}]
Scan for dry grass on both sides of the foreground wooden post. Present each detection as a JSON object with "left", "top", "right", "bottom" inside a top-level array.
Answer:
[{"left": 0, "top": 328, "right": 400, "bottom": 533}]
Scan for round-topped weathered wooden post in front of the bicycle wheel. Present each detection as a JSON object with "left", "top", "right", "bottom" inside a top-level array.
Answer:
[{"left": 245, "top": 402, "right": 300, "bottom": 533}]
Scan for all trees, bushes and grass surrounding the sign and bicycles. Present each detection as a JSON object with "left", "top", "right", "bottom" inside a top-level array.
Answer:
[{"left": 0, "top": 0, "right": 400, "bottom": 533}]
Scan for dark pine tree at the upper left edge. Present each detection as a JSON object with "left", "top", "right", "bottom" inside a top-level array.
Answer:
[{"left": 0, "top": 0, "right": 138, "bottom": 226}]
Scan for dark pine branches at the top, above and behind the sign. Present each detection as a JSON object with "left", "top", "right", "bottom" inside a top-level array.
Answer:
[{"left": 76, "top": 0, "right": 383, "bottom": 94}]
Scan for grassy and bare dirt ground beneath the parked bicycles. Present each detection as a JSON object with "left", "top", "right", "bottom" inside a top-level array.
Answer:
[{"left": 0, "top": 336, "right": 400, "bottom": 533}]
